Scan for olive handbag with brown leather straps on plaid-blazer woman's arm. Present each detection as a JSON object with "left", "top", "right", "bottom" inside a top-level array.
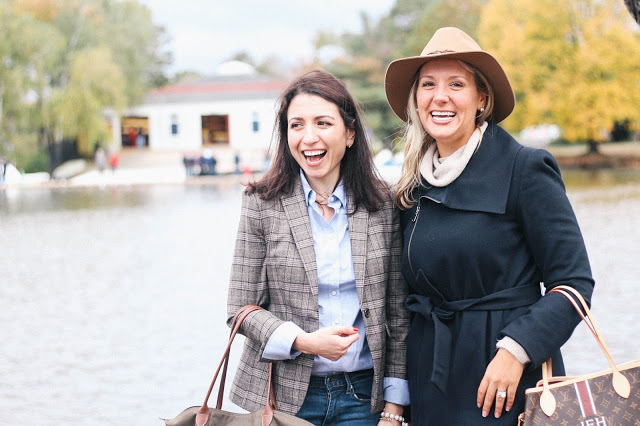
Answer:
[{"left": 164, "top": 305, "right": 313, "bottom": 426}]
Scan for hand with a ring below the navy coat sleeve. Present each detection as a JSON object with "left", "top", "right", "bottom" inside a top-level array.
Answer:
[{"left": 477, "top": 348, "right": 524, "bottom": 418}]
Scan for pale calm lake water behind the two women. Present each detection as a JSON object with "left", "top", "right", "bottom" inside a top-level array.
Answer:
[{"left": 0, "top": 171, "right": 640, "bottom": 425}]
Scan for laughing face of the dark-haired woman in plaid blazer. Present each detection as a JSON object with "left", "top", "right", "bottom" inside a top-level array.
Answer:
[{"left": 287, "top": 93, "right": 355, "bottom": 192}]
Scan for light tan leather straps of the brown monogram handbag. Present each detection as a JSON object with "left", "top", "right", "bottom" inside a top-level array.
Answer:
[{"left": 540, "top": 285, "right": 631, "bottom": 417}]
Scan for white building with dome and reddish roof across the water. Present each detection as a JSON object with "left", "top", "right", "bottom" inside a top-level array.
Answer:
[{"left": 108, "top": 61, "right": 288, "bottom": 173}]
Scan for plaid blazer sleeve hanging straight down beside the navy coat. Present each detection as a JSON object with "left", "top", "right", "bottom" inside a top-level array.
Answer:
[{"left": 385, "top": 203, "right": 410, "bottom": 379}]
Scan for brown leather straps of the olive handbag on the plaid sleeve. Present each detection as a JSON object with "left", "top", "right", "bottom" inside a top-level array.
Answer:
[{"left": 196, "top": 305, "right": 277, "bottom": 426}]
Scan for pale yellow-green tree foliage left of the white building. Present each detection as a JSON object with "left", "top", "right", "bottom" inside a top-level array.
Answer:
[{"left": 0, "top": 0, "right": 172, "bottom": 166}]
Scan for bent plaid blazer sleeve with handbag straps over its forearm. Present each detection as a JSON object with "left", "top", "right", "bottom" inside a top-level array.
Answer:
[{"left": 227, "top": 193, "right": 284, "bottom": 361}]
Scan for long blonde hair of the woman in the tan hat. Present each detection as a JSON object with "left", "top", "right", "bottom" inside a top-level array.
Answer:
[{"left": 396, "top": 60, "right": 495, "bottom": 210}]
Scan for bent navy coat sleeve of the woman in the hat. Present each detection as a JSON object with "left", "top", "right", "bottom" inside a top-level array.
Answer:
[{"left": 501, "top": 148, "right": 594, "bottom": 368}]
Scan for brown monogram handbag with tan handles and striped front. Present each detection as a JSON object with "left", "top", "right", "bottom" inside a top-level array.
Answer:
[{"left": 518, "top": 286, "right": 640, "bottom": 426}]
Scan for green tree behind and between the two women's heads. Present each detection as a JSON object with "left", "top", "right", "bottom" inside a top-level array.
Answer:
[{"left": 315, "top": 0, "right": 486, "bottom": 149}]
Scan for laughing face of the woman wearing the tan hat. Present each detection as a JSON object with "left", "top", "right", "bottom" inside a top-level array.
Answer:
[{"left": 416, "top": 59, "right": 486, "bottom": 157}]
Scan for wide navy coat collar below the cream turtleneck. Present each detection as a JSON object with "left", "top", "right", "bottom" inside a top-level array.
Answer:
[{"left": 418, "top": 122, "right": 522, "bottom": 214}]
